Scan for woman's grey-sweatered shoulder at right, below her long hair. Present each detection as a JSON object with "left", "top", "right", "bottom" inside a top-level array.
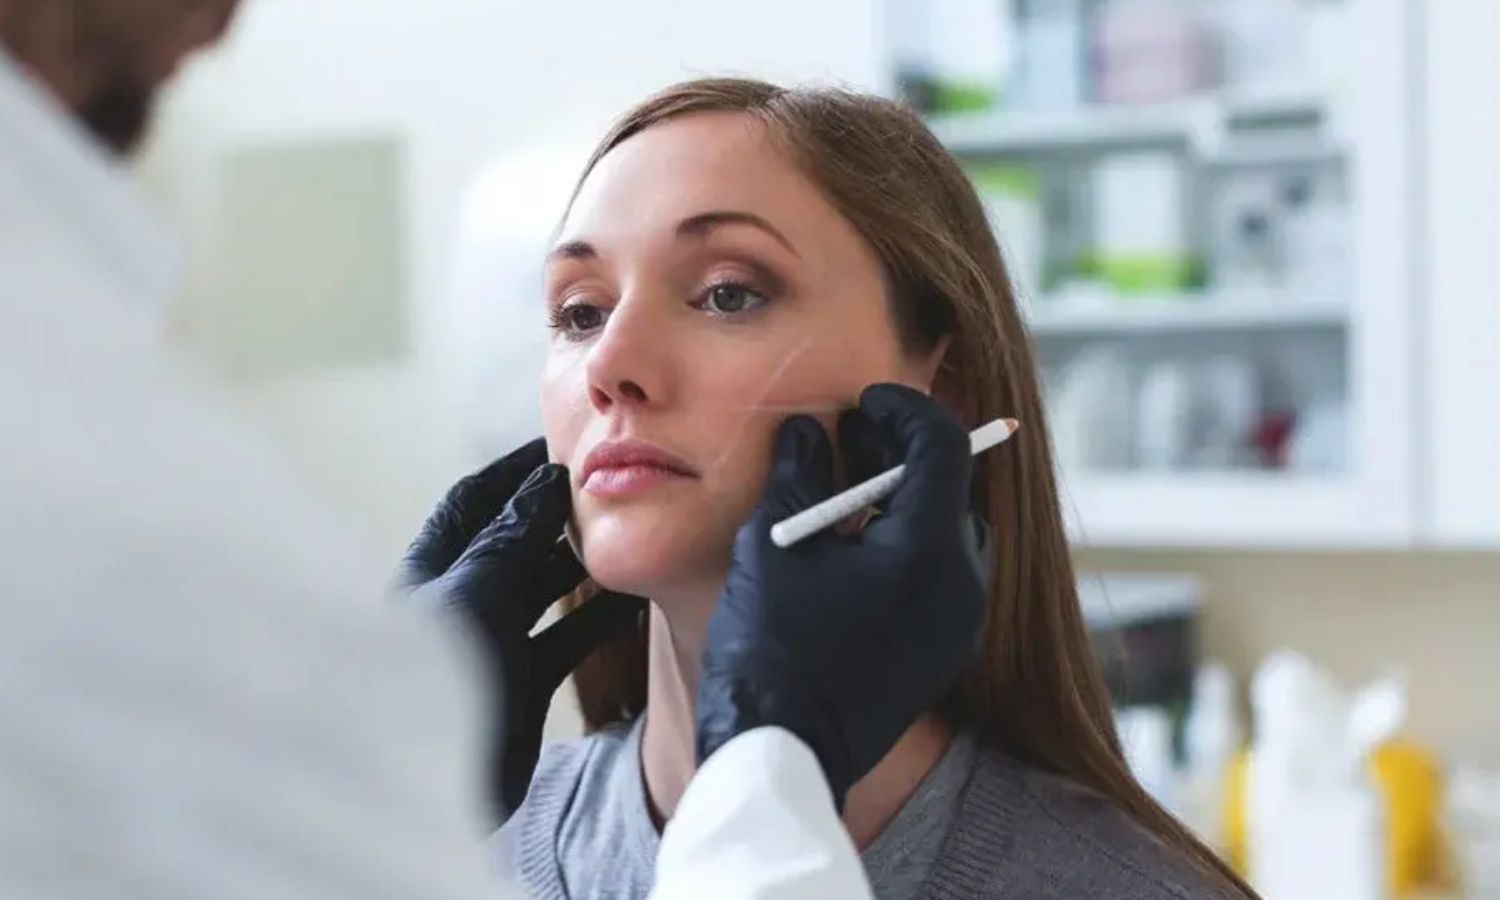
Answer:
[{"left": 944, "top": 749, "right": 1232, "bottom": 900}]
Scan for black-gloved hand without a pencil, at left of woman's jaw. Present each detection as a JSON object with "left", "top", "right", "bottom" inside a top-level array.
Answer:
[{"left": 398, "top": 438, "right": 645, "bottom": 822}]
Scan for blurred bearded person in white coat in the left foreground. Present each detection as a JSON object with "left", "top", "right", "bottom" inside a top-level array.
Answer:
[{"left": 0, "top": 0, "right": 494, "bottom": 900}]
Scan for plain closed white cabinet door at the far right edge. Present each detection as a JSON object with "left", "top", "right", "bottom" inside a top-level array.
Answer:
[{"left": 1418, "top": 0, "right": 1500, "bottom": 546}]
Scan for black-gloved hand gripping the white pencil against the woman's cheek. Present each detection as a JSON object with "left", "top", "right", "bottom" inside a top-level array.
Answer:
[{"left": 698, "top": 384, "right": 986, "bottom": 807}]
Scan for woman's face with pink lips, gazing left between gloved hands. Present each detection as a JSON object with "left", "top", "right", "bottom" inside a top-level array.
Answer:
[{"left": 542, "top": 113, "right": 930, "bottom": 599}]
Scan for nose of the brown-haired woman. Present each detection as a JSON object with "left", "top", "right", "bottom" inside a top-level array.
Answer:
[{"left": 588, "top": 299, "right": 671, "bottom": 413}]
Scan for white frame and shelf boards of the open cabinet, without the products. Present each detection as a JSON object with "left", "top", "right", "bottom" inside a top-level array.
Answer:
[{"left": 932, "top": 0, "right": 1416, "bottom": 548}]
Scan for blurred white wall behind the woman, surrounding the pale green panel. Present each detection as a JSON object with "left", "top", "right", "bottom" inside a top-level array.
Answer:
[{"left": 143, "top": 0, "right": 885, "bottom": 540}]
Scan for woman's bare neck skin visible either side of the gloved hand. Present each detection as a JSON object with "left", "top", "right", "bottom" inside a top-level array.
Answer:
[{"left": 641, "top": 603, "right": 951, "bottom": 849}]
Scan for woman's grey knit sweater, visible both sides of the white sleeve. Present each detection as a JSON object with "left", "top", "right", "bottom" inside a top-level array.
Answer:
[{"left": 498, "top": 731, "right": 1230, "bottom": 900}]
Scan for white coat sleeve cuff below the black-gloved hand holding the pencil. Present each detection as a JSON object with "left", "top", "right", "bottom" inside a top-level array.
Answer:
[{"left": 651, "top": 728, "right": 872, "bottom": 900}]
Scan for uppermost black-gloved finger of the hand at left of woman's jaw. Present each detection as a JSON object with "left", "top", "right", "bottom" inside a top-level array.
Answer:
[{"left": 396, "top": 438, "right": 548, "bottom": 590}]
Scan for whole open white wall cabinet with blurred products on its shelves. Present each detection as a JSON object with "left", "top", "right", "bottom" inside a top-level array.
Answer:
[{"left": 894, "top": 0, "right": 1424, "bottom": 548}]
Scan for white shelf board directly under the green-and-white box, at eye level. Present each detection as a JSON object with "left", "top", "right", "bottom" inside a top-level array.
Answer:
[{"left": 1026, "top": 297, "right": 1349, "bottom": 338}]
